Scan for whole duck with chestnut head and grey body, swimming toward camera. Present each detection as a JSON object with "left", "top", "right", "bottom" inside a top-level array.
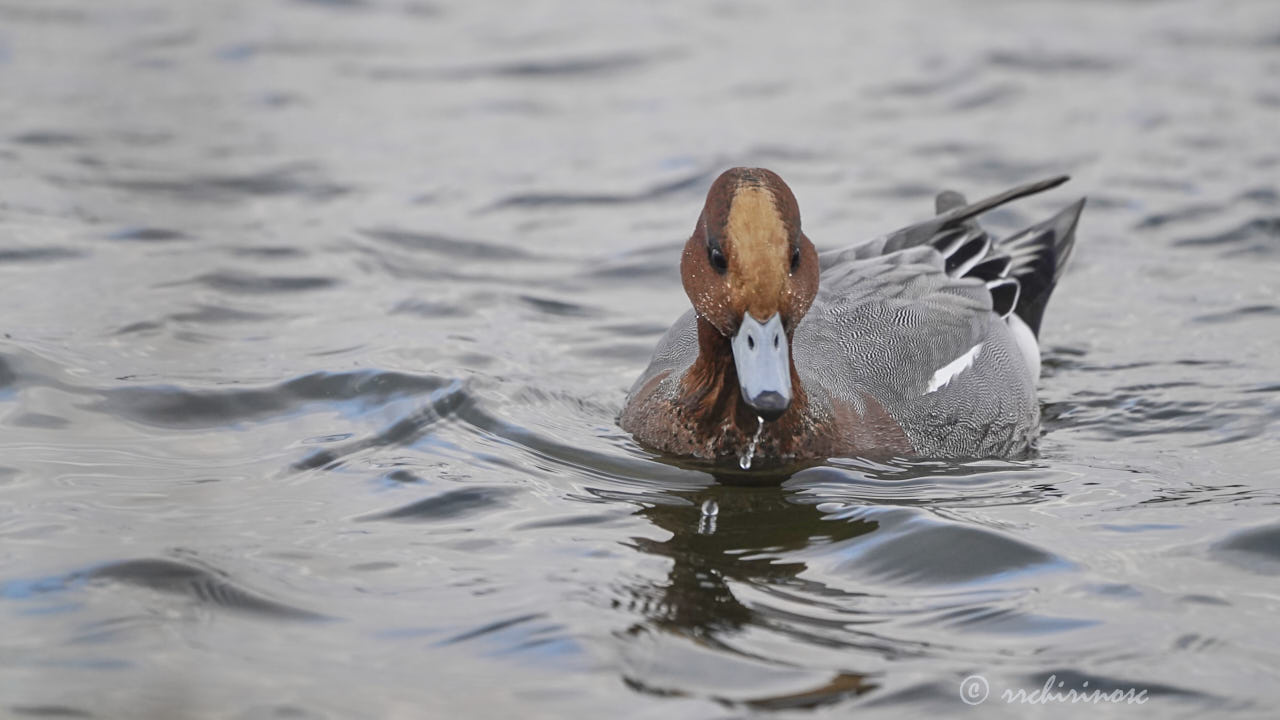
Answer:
[{"left": 618, "top": 168, "right": 1084, "bottom": 458}]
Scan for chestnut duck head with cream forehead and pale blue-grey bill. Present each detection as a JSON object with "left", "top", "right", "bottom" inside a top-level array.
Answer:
[{"left": 680, "top": 168, "right": 818, "bottom": 420}]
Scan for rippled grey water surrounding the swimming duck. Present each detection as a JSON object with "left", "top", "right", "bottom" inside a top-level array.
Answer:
[{"left": 0, "top": 0, "right": 1280, "bottom": 720}]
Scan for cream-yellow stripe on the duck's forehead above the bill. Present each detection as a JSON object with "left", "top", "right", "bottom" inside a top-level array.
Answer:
[{"left": 724, "top": 186, "right": 788, "bottom": 302}]
